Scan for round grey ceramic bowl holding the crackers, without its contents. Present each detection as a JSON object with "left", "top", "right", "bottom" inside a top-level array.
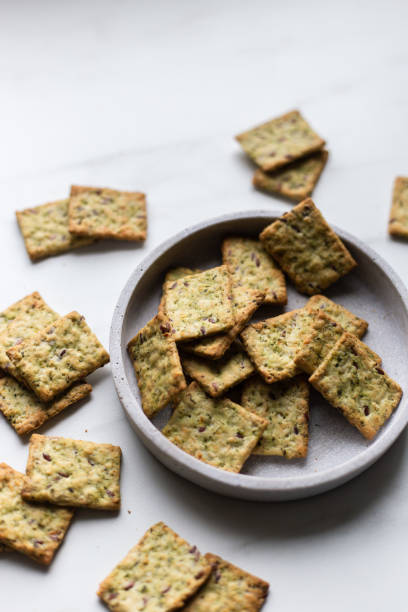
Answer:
[{"left": 110, "top": 211, "right": 408, "bottom": 501}]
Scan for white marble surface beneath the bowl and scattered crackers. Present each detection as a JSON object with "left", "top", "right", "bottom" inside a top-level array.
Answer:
[{"left": 0, "top": 0, "right": 408, "bottom": 612}]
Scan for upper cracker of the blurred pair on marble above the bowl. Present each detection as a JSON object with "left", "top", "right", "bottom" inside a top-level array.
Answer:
[{"left": 236, "top": 110, "right": 325, "bottom": 172}]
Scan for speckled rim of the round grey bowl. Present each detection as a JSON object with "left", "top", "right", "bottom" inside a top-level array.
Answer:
[{"left": 110, "top": 210, "right": 408, "bottom": 501}]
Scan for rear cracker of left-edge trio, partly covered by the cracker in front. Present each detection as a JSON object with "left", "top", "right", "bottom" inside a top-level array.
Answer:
[{"left": 0, "top": 292, "right": 59, "bottom": 377}]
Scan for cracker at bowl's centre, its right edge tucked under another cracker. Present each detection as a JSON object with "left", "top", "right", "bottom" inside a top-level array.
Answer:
[{"left": 241, "top": 308, "right": 314, "bottom": 383}]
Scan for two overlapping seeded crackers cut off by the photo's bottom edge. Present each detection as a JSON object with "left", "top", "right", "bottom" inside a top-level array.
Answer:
[{"left": 98, "top": 523, "right": 269, "bottom": 612}]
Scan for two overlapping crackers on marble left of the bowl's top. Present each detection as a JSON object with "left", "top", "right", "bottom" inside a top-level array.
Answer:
[{"left": 16, "top": 185, "right": 147, "bottom": 261}]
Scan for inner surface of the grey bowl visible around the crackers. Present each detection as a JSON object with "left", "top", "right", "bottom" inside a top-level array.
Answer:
[{"left": 116, "top": 213, "right": 408, "bottom": 488}]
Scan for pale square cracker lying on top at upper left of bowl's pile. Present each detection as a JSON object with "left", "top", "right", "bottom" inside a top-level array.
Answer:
[{"left": 164, "top": 266, "right": 234, "bottom": 341}]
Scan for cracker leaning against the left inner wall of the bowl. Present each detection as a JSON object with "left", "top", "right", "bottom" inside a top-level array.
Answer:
[{"left": 128, "top": 316, "right": 186, "bottom": 417}]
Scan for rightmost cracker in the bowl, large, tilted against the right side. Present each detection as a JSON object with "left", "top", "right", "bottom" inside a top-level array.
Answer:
[{"left": 309, "top": 332, "right": 402, "bottom": 440}]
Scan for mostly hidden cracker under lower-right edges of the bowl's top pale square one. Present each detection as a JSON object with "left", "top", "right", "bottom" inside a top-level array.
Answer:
[{"left": 183, "top": 286, "right": 265, "bottom": 359}]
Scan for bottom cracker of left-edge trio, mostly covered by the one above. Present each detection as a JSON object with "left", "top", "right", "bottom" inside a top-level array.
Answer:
[{"left": 0, "top": 376, "right": 92, "bottom": 436}]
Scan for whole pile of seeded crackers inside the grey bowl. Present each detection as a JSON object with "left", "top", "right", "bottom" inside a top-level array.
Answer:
[{"left": 128, "top": 198, "right": 402, "bottom": 472}]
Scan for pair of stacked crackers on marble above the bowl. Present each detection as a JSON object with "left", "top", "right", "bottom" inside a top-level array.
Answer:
[{"left": 236, "top": 110, "right": 329, "bottom": 202}]
